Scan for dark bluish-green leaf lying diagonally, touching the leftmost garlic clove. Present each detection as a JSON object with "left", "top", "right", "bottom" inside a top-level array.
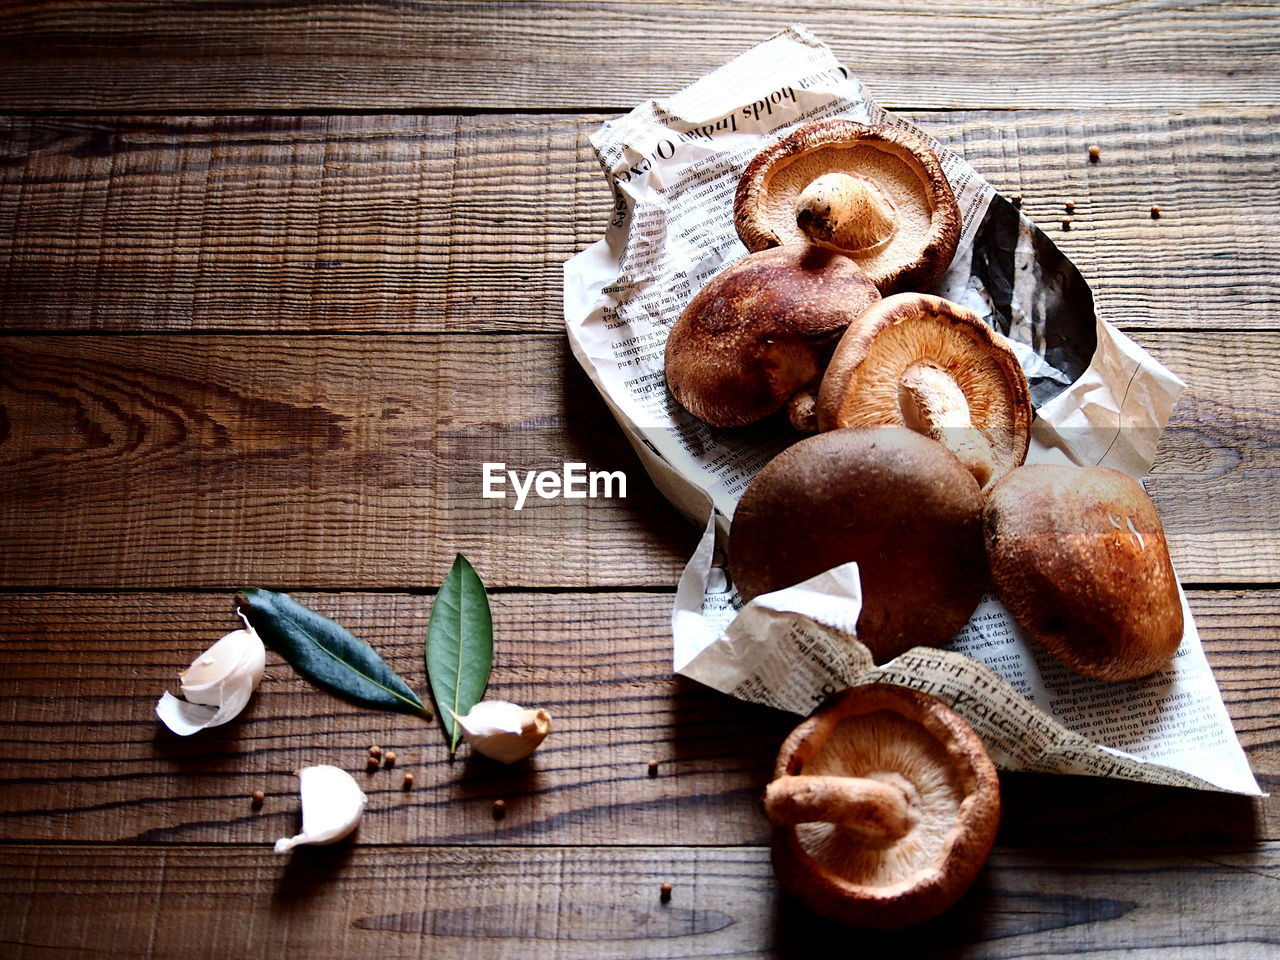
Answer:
[{"left": 237, "top": 588, "right": 431, "bottom": 718}]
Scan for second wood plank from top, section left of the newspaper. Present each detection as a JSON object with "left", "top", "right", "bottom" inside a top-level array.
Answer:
[{"left": 0, "top": 116, "right": 609, "bottom": 332}]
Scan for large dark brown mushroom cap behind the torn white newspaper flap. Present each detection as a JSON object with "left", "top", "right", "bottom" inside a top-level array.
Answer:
[{"left": 728, "top": 428, "right": 987, "bottom": 663}]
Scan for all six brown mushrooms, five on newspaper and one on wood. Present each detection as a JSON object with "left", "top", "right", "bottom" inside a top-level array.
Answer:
[{"left": 666, "top": 120, "right": 1183, "bottom": 928}]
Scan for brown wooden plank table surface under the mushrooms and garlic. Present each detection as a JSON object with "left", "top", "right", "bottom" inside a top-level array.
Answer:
[{"left": 0, "top": 0, "right": 1280, "bottom": 960}]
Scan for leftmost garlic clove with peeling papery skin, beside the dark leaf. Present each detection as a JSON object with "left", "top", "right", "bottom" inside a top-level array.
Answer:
[{"left": 156, "top": 621, "right": 266, "bottom": 736}]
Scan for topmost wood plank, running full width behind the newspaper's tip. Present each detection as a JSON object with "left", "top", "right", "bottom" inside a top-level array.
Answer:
[{"left": 0, "top": 0, "right": 1280, "bottom": 113}]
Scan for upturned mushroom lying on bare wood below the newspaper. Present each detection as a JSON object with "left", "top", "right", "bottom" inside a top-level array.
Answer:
[{"left": 765, "top": 684, "right": 1000, "bottom": 929}]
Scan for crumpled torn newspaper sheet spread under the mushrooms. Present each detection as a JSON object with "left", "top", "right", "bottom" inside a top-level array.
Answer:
[{"left": 564, "top": 27, "right": 1261, "bottom": 795}]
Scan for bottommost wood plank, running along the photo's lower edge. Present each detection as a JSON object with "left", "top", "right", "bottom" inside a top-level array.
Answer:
[{"left": 0, "top": 844, "right": 1280, "bottom": 960}]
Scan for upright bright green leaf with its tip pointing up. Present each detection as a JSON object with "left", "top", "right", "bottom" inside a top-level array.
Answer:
[{"left": 426, "top": 553, "right": 493, "bottom": 753}]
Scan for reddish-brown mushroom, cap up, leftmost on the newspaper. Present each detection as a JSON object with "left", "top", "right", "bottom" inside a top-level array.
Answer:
[{"left": 666, "top": 244, "right": 879, "bottom": 430}]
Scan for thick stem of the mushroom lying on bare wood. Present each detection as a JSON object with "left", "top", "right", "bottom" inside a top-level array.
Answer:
[{"left": 764, "top": 776, "right": 918, "bottom": 847}]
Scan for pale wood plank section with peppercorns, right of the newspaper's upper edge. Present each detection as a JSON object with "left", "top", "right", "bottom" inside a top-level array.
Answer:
[{"left": 913, "top": 110, "right": 1280, "bottom": 330}]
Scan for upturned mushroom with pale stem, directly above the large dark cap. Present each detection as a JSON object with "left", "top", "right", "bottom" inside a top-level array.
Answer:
[{"left": 818, "top": 293, "right": 1034, "bottom": 488}]
